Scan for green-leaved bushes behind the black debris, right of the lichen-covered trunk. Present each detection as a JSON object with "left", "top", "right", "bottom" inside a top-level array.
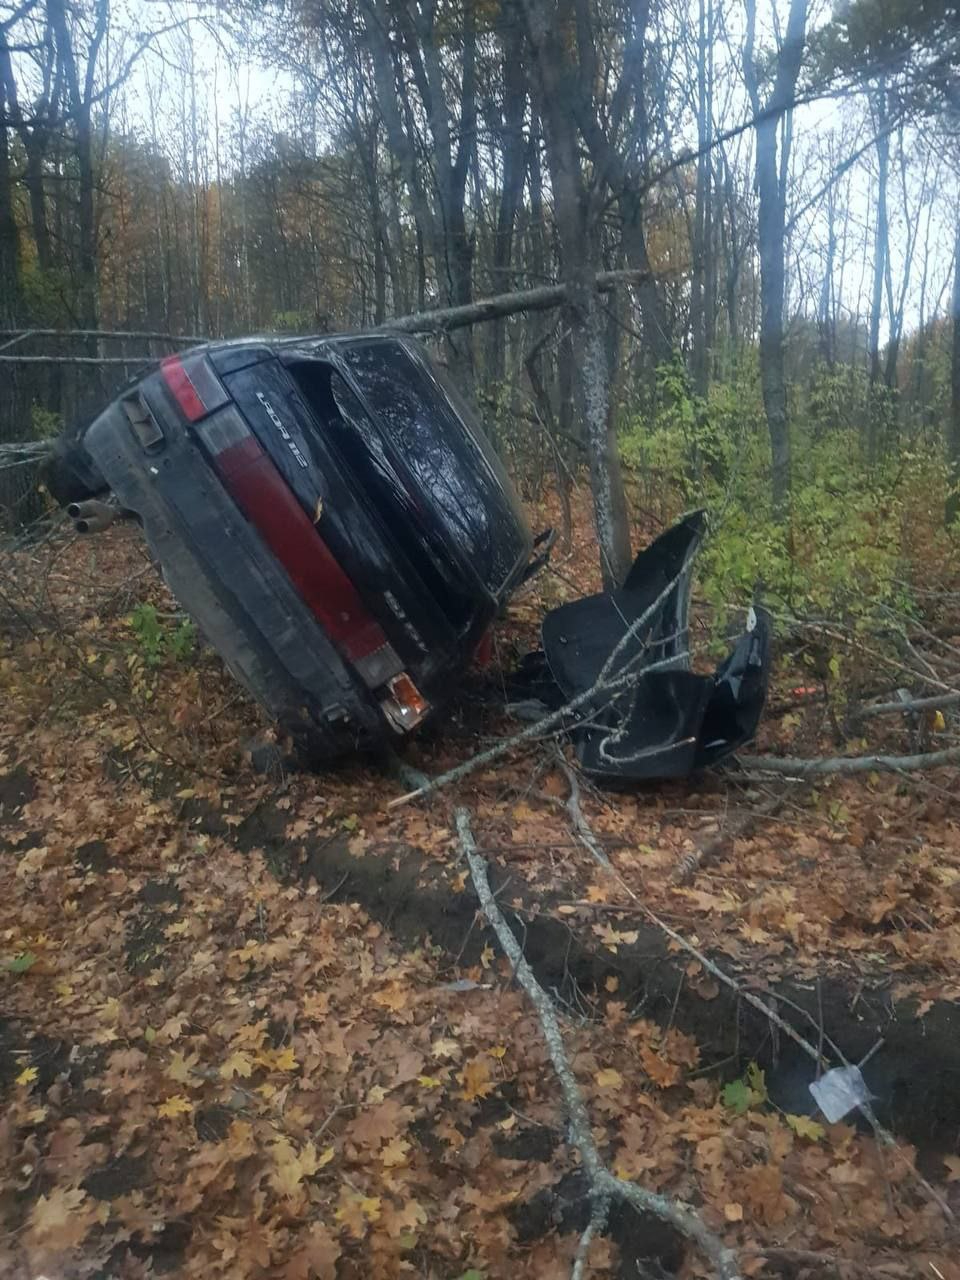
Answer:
[{"left": 621, "top": 367, "right": 957, "bottom": 650}]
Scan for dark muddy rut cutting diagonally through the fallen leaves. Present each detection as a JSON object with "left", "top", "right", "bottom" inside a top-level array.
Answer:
[{"left": 176, "top": 768, "right": 960, "bottom": 1158}]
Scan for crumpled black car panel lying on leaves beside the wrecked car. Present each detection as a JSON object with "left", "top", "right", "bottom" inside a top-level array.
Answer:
[{"left": 535, "top": 511, "right": 771, "bottom": 781}]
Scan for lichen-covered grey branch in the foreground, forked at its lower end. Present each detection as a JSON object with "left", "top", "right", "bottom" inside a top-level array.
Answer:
[{"left": 456, "top": 809, "right": 740, "bottom": 1280}]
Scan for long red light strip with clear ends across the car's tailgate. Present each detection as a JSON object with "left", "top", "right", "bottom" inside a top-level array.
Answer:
[{"left": 195, "top": 406, "right": 403, "bottom": 689}]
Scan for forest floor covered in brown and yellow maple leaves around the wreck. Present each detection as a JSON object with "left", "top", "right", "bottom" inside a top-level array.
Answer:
[{"left": 0, "top": 494, "right": 960, "bottom": 1280}]
